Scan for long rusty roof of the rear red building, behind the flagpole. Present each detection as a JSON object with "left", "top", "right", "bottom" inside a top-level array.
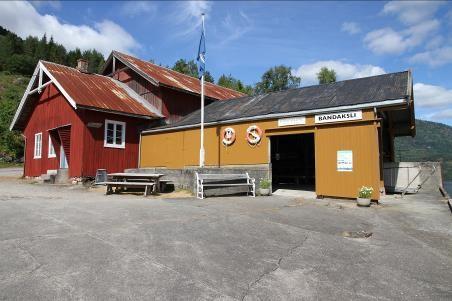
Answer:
[{"left": 112, "top": 51, "right": 245, "bottom": 100}]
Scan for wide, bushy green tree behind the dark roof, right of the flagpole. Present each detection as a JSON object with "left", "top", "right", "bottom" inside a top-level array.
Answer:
[{"left": 256, "top": 65, "right": 301, "bottom": 94}]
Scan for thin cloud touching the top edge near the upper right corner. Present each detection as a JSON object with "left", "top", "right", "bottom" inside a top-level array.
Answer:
[{"left": 382, "top": 1, "right": 446, "bottom": 25}]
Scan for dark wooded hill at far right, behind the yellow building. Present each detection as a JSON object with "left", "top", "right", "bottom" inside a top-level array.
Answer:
[{"left": 395, "top": 119, "right": 452, "bottom": 181}]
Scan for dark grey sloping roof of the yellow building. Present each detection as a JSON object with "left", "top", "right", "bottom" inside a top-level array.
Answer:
[{"left": 149, "top": 71, "right": 412, "bottom": 131}]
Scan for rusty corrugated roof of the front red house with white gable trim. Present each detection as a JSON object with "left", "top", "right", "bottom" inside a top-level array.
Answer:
[{"left": 41, "top": 61, "right": 160, "bottom": 117}]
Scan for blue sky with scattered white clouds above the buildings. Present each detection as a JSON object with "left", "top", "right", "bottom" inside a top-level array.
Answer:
[{"left": 0, "top": 1, "right": 452, "bottom": 125}]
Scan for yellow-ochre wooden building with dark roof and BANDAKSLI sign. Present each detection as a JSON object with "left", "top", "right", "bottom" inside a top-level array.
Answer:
[{"left": 139, "top": 71, "right": 415, "bottom": 200}]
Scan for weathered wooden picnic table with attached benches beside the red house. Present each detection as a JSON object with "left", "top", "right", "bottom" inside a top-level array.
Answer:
[{"left": 97, "top": 172, "right": 164, "bottom": 196}]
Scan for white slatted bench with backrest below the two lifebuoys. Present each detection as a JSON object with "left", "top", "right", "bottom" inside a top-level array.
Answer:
[{"left": 196, "top": 172, "right": 256, "bottom": 199}]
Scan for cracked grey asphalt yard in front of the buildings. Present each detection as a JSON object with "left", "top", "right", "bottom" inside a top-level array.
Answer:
[{"left": 0, "top": 178, "right": 452, "bottom": 300}]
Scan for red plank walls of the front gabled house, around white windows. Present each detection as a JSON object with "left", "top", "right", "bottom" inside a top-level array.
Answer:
[{"left": 24, "top": 85, "right": 149, "bottom": 177}]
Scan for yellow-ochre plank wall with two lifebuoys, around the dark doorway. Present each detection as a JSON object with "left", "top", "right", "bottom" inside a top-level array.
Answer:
[{"left": 140, "top": 110, "right": 380, "bottom": 199}]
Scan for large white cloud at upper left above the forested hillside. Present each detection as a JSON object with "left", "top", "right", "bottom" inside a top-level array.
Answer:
[{"left": 0, "top": 1, "right": 140, "bottom": 56}]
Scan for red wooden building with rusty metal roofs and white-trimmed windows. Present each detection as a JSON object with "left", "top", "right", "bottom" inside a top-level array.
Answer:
[{"left": 11, "top": 52, "right": 242, "bottom": 177}]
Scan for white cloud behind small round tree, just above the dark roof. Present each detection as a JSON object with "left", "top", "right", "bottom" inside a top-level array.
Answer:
[{"left": 293, "top": 60, "right": 386, "bottom": 86}]
